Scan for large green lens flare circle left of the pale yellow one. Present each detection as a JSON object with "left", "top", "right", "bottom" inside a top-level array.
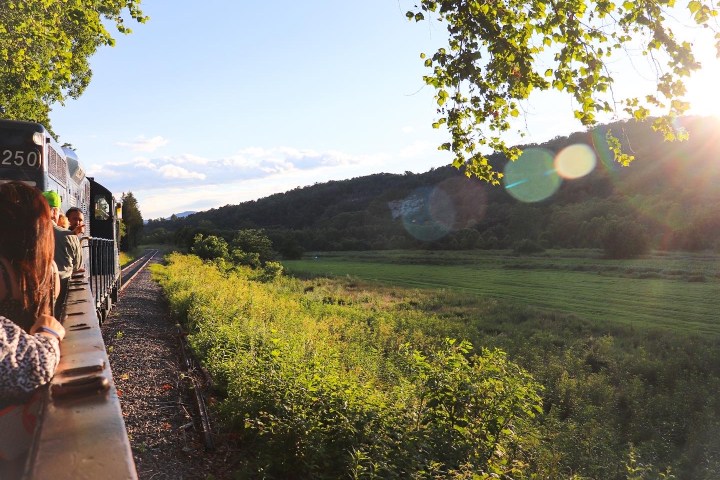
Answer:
[{"left": 503, "top": 148, "right": 562, "bottom": 203}]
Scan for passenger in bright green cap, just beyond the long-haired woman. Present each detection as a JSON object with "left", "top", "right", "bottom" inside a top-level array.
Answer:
[{"left": 43, "top": 192, "right": 85, "bottom": 316}]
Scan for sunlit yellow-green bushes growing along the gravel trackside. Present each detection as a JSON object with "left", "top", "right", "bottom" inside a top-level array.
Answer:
[{"left": 156, "top": 254, "right": 540, "bottom": 479}]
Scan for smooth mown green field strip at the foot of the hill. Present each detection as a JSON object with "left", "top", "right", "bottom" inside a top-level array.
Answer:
[{"left": 283, "top": 251, "right": 720, "bottom": 335}]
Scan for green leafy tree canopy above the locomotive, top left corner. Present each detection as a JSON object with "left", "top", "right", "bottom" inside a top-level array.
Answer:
[{"left": 0, "top": 0, "right": 147, "bottom": 128}]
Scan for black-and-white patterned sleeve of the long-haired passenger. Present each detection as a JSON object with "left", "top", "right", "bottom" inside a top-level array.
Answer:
[{"left": 0, "top": 316, "right": 60, "bottom": 397}]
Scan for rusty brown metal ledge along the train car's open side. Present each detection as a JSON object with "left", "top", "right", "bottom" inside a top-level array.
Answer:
[{"left": 22, "top": 268, "right": 137, "bottom": 480}]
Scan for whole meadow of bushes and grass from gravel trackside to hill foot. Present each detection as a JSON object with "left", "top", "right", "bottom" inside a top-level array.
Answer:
[{"left": 154, "top": 251, "right": 720, "bottom": 480}]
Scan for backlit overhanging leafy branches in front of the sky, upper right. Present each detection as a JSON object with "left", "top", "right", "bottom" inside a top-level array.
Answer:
[{"left": 406, "top": 0, "right": 720, "bottom": 184}]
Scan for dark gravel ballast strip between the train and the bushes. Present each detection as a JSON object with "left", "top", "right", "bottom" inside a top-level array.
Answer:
[{"left": 102, "top": 262, "right": 230, "bottom": 480}]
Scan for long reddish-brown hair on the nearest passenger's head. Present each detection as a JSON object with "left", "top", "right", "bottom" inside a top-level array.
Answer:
[{"left": 0, "top": 182, "right": 55, "bottom": 316}]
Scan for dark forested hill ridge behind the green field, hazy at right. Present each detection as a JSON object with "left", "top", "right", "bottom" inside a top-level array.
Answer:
[{"left": 145, "top": 117, "right": 720, "bottom": 256}]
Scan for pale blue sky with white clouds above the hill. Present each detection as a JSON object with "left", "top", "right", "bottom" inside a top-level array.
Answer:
[{"left": 50, "top": 0, "right": 720, "bottom": 219}]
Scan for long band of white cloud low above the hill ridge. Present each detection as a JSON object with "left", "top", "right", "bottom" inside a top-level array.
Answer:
[{"left": 89, "top": 141, "right": 446, "bottom": 218}]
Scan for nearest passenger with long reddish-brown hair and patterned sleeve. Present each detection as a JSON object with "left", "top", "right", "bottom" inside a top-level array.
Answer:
[{"left": 0, "top": 182, "right": 65, "bottom": 464}]
